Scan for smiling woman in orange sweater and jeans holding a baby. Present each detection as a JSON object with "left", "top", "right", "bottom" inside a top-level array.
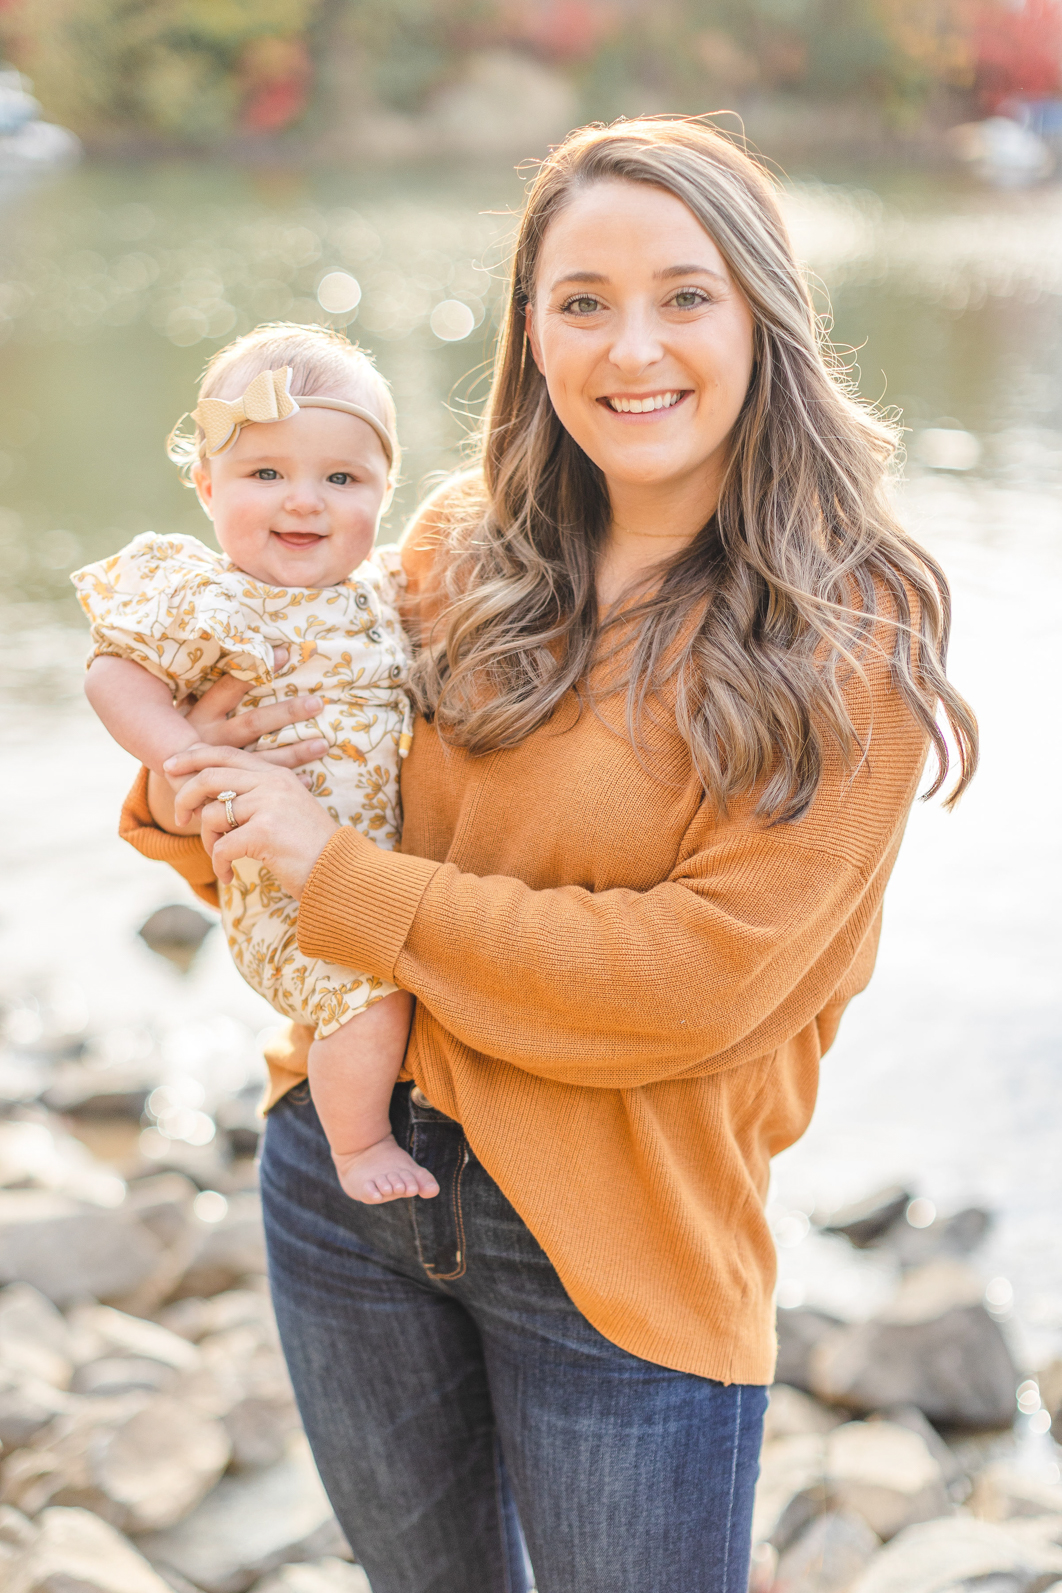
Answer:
[{"left": 126, "top": 119, "right": 976, "bottom": 1593}]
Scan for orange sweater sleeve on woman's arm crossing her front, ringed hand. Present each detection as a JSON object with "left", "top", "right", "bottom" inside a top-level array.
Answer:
[{"left": 299, "top": 691, "right": 925, "bottom": 1088}]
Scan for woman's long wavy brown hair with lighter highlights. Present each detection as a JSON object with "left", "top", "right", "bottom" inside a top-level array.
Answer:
[{"left": 414, "top": 118, "right": 978, "bottom": 820}]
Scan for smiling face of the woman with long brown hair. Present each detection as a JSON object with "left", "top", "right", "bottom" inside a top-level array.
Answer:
[{"left": 527, "top": 178, "right": 753, "bottom": 505}]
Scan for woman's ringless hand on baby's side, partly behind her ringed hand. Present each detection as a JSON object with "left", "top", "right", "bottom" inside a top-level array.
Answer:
[{"left": 148, "top": 648, "right": 328, "bottom": 835}]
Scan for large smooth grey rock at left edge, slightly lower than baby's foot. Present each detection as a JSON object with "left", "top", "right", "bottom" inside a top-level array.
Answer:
[{"left": 0, "top": 1190, "right": 161, "bottom": 1305}]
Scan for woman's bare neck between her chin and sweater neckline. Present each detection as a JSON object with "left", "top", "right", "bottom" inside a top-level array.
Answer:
[{"left": 597, "top": 478, "right": 718, "bottom": 609}]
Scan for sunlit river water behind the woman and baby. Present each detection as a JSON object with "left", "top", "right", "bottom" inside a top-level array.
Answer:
[{"left": 0, "top": 166, "right": 1062, "bottom": 1367}]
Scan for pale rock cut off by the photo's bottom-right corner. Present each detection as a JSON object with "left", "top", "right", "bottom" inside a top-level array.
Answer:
[{"left": 850, "top": 1515, "right": 1062, "bottom": 1593}]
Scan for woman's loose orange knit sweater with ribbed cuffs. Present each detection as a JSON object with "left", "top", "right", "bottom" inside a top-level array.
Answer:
[{"left": 123, "top": 512, "right": 927, "bottom": 1383}]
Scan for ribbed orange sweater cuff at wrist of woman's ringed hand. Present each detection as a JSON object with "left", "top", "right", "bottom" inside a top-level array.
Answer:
[{"left": 298, "top": 825, "right": 439, "bottom": 981}]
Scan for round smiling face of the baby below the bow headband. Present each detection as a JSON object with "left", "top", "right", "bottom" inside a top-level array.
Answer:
[{"left": 193, "top": 393, "right": 388, "bottom": 586}]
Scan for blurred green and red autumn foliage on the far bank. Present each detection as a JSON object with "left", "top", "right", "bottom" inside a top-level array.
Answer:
[{"left": 0, "top": 0, "right": 1062, "bottom": 145}]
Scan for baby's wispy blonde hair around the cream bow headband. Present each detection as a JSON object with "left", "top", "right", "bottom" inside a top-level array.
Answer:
[{"left": 166, "top": 320, "right": 401, "bottom": 486}]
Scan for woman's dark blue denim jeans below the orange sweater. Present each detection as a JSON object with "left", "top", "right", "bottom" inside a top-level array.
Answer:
[{"left": 261, "top": 1085, "right": 766, "bottom": 1593}]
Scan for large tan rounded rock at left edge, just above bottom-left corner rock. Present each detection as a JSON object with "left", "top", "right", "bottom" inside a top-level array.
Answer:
[{"left": 0, "top": 1394, "right": 231, "bottom": 1532}]
